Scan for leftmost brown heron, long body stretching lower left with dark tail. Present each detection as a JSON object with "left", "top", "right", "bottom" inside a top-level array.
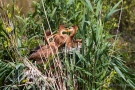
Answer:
[{"left": 29, "top": 30, "right": 58, "bottom": 64}]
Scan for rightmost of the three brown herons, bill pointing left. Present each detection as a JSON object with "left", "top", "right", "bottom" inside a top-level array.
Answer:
[{"left": 66, "top": 26, "right": 82, "bottom": 49}]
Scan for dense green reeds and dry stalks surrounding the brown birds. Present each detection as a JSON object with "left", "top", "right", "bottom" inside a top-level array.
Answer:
[{"left": 0, "top": 0, "right": 135, "bottom": 90}]
